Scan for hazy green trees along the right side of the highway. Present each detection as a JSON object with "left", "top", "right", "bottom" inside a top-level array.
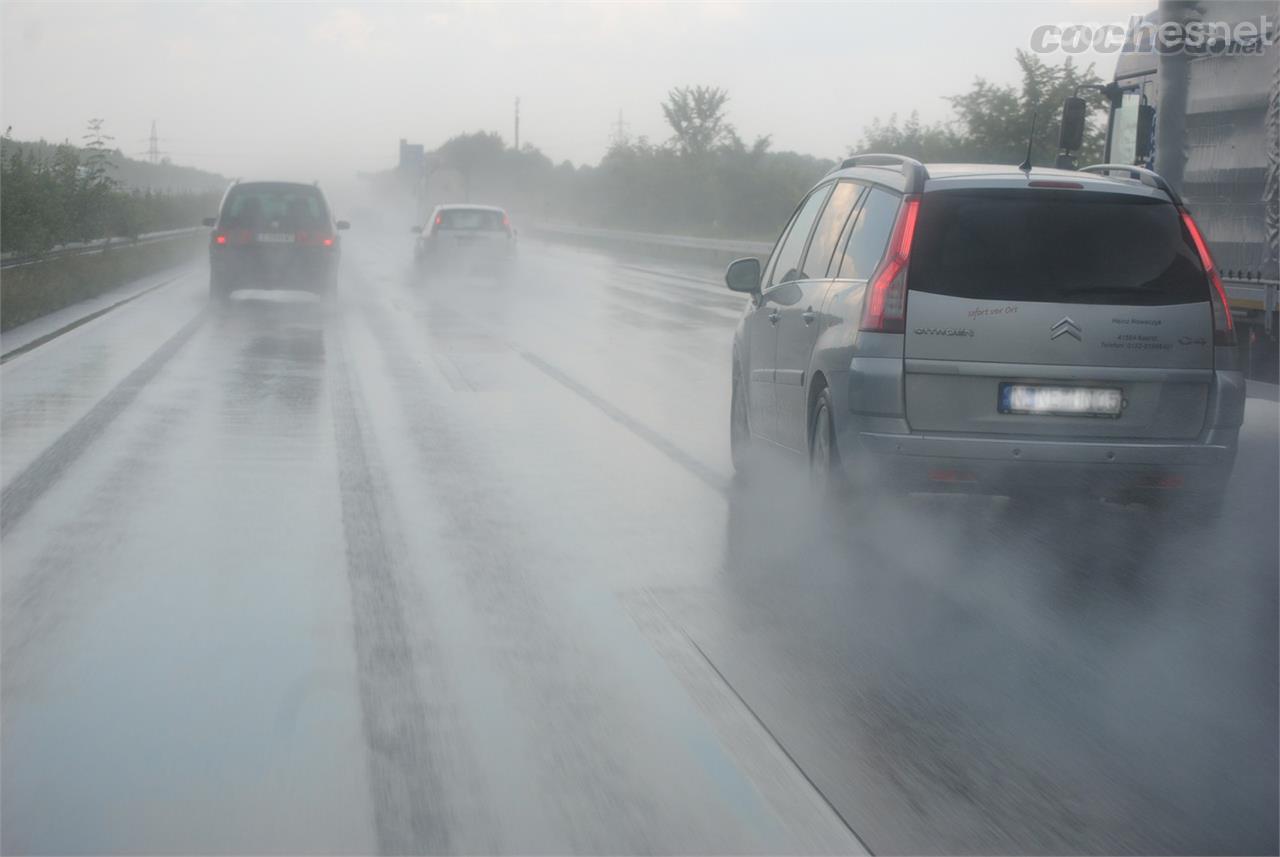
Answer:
[{"left": 401, "top": 51, "right": 1105, "bottom": 238}]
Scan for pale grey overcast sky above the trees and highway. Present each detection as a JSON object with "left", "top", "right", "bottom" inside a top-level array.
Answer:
[{"left": 0, "top": 0, "right": 1131, "bottom": 178}]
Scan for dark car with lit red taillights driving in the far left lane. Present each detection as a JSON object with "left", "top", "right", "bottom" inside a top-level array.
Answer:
[{"left": 205, "top": 182, "right": 349, "bottom": 301}]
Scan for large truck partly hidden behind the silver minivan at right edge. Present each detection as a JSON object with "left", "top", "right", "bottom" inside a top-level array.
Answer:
[{"left": 1070, "top": 0, "right": 1280, "bottom": 381}]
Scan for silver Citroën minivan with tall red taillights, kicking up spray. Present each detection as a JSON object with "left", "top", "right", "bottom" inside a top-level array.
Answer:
[{"left": 726, "top": 155, "right": 1244, "bottom": 514}]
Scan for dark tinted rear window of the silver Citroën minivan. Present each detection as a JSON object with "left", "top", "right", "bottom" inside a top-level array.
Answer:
[{"left": 908, "top": 189, "right": 1210, "bottom": 306}]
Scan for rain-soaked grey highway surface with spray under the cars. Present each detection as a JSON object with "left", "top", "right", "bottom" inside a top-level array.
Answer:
[{"left": 0, "top": 232, "right": 1280, "bottom": 853}]
